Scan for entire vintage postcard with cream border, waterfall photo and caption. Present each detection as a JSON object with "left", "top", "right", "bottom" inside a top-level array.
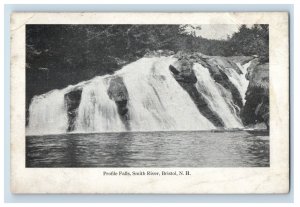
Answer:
[{"left": 10, "top": 12, "right": 289, "bottom": 194}]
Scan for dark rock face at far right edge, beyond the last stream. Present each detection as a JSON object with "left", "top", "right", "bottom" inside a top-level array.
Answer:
[{"left": 241, "top": 59, "right": 269, "bottom": 129}]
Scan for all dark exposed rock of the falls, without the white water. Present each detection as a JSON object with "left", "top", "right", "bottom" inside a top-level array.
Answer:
[{"left": 64, "top": 51, "right": 269, "bottom": 131}]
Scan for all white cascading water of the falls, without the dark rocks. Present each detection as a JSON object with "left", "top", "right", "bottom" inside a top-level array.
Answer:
[{"left": 26, "top": 57, "right": 249, "bottom": 134}]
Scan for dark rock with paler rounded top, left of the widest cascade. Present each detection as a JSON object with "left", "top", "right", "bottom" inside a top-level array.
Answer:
[{"left": 107, "top": 76, "right": 130, "bottom": 130}]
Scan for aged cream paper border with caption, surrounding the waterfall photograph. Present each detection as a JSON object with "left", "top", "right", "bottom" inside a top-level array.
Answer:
[{"left": 10, "top": 12, "right": 289, "bottom": 194}]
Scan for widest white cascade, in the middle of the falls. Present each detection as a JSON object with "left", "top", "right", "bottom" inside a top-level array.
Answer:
[{"left": 117, "top": 57, "right": 215, "bottom": 131}]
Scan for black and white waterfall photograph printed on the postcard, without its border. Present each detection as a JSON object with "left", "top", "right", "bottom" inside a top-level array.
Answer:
[{"left": 25, "top": 24, "right": 270, "bottom": 168}]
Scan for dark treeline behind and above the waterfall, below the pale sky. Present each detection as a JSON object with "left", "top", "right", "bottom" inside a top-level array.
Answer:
[{"left": 26, "top": 25, "right": 269, "bottom": 105}]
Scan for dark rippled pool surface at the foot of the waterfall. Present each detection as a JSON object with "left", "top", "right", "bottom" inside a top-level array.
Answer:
[{"left": 26, "top": 131, "right": 270, "bottom": 167}]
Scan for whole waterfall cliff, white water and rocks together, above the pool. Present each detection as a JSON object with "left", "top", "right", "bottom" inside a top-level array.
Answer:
[{"left": 28, "top": 50, "right": 269, "bottom": 133}]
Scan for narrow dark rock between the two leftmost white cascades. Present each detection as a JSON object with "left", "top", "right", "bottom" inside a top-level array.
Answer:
[{"left": 64, "top": 88, "right": 82, "bottom": 132}]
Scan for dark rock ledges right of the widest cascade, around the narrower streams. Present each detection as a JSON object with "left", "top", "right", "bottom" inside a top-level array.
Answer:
[{"left": 147, "top": 51, "right": 269, "bottom": 129}]
